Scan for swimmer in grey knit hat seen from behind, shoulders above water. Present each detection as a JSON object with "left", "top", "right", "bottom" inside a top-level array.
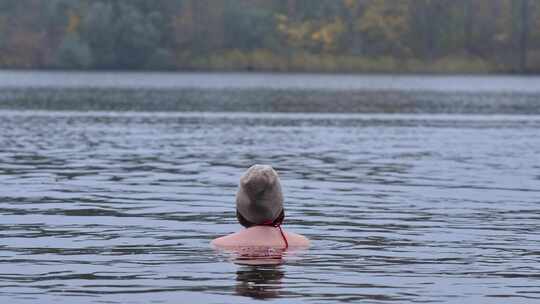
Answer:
[{"left": 212, "top": 165, "right": 309, "bottom": 249}]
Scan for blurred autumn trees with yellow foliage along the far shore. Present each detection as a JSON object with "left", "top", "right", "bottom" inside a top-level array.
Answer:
[{"left": 0, "top": 0, "right": 540, "bottom": 73}]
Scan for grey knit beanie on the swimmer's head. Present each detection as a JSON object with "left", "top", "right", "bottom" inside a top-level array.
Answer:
[{"left": 236, "top": 165, "right": 283, "bottom": 224}]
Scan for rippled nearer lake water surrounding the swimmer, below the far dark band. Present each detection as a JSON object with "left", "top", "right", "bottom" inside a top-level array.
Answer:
[{"left": 0, "top": 72, "right": 540, "bottom": 303}]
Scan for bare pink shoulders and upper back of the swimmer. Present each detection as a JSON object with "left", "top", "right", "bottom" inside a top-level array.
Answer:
[{"left": 212, "top": 226, "right": 309, "bottom": 248}]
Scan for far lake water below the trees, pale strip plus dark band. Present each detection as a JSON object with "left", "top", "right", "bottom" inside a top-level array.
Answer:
[{"left": 0, "top": 71, "right": 540, "bottom": 115}]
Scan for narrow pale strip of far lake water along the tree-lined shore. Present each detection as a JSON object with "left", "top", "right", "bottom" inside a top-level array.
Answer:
[{"left": 0, "top": 70, "right": 540, "bottom": 93}]
